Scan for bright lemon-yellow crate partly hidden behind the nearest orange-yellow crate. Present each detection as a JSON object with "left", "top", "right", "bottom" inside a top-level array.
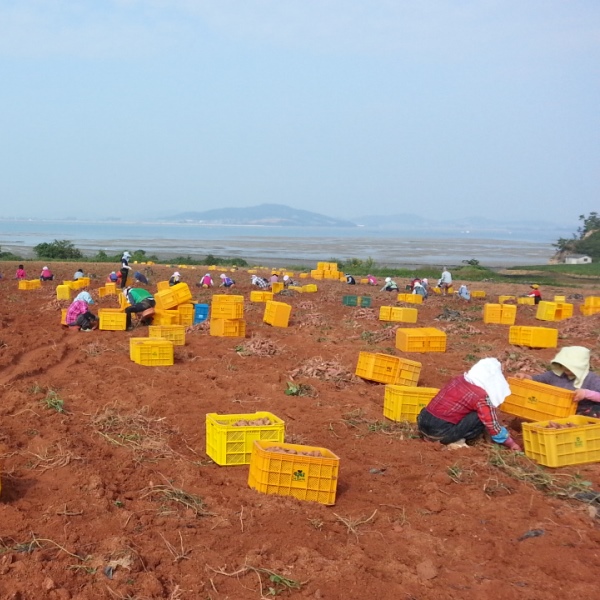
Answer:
[{"left": 206, "top": 412, "right": 285, "bottom": 466}]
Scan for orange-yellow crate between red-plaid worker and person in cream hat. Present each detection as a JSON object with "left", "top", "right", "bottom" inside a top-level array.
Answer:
[{"left": 500, "top": 377, "right": 577, "bottom": 421}]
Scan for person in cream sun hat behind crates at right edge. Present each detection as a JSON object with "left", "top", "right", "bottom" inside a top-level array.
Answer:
[{"left": 522, "top": 346, "right": 600, "bottom": 418}]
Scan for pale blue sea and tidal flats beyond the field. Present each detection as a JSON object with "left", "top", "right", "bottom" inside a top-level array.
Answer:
[{"left": 0, "top": 220, "right": 570, "bottom": 266}]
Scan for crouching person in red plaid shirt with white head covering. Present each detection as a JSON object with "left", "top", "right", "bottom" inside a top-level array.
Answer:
[{"left": 417, "top": 358, "right": 521, "bottom": 451}]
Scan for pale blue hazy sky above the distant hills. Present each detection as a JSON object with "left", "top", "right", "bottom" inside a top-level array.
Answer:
[{"left": 0, "top": 0, "right": 600, "bottom": 225}]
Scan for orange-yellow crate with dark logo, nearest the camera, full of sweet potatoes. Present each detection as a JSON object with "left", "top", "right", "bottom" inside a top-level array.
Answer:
[{"left": 248, "top": 440, "right": 340, "bottom": 505}]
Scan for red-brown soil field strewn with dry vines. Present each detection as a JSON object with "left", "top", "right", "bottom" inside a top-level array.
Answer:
[{"left": 0, "top": 263, "right": 600, "bottom": 600}]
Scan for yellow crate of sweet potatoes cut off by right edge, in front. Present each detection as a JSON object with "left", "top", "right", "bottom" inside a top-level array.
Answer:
[{"left": 523, "top": 415, "right": 600, "bottom": 467}]
